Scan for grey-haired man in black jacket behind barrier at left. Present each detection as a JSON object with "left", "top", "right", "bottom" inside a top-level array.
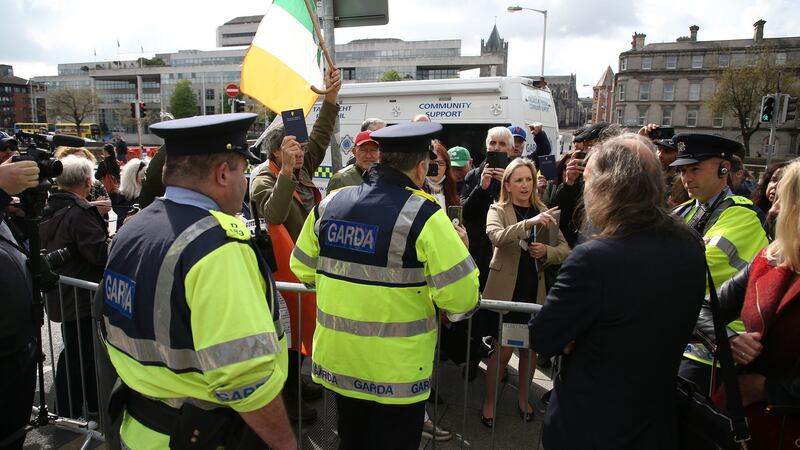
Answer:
[{"left": 40, "top": 155, "right": 108, "bottom": 418}]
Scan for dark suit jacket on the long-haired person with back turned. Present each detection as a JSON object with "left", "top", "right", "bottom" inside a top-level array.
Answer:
[{"left": 531, "top": 230, "right": 705, "bottom": 450}]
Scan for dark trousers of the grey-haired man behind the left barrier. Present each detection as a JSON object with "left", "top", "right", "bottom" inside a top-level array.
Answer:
[{"left": 55, "top": 317, "right": 97, "bottom": 419}]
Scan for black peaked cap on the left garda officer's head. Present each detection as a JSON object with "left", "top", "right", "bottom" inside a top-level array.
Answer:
[{"left": 150, "top": 113, "right": 260, "bottom": 163}]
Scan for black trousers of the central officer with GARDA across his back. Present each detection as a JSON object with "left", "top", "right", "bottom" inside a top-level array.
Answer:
[{"left": 335, "top": 394, "right": 425, "bottom": 450}]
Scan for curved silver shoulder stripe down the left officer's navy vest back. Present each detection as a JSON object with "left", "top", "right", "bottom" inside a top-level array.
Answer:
[{"left": 153, "top": 216, "right": 219, "bottom": 347}]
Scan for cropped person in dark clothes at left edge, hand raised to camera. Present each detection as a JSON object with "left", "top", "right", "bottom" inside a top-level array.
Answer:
[{"left": 0, "top": 156, "right": 39, "bottom": 449}]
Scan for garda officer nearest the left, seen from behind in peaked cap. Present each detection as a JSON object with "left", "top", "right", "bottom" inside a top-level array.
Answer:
[{"left": 101, "top": 113, "right": 296, "bottom": 450}]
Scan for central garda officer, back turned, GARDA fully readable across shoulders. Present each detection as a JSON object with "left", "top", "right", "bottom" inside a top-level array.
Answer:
[{"left": 290, "top": 122, "right": 478, "bottom": 449}]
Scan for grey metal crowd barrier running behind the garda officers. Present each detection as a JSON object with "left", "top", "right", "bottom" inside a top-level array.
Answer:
[{"left": 42, "top": 276, "right": 541, "bottom": 449}]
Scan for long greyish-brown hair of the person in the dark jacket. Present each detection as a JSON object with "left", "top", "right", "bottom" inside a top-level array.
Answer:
[{"left": 583, "top": 133, "right": 680, "bottom": 238}]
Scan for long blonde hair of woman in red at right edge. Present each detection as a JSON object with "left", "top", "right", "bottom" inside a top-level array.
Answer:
[{"left": 766, "top": 160, "right": 800, "bottom": 272}]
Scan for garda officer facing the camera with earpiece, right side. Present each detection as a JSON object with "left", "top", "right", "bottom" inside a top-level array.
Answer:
[{"left": 670, "top": 133, "right": 768, "bottom": 390}]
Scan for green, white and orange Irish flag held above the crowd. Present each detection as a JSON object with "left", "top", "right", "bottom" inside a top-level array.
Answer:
[{"left": 241, "top": 0, "right": 322, "bottom": 115}]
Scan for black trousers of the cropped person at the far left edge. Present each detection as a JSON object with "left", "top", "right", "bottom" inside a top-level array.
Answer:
[{"left": 0, "top": 341, "right": 36, "bottom": 450}]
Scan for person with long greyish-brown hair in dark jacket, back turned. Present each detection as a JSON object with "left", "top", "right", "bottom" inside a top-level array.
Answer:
[{"left": 531, "top": 134, "right": 705, "bottom": 449}]
